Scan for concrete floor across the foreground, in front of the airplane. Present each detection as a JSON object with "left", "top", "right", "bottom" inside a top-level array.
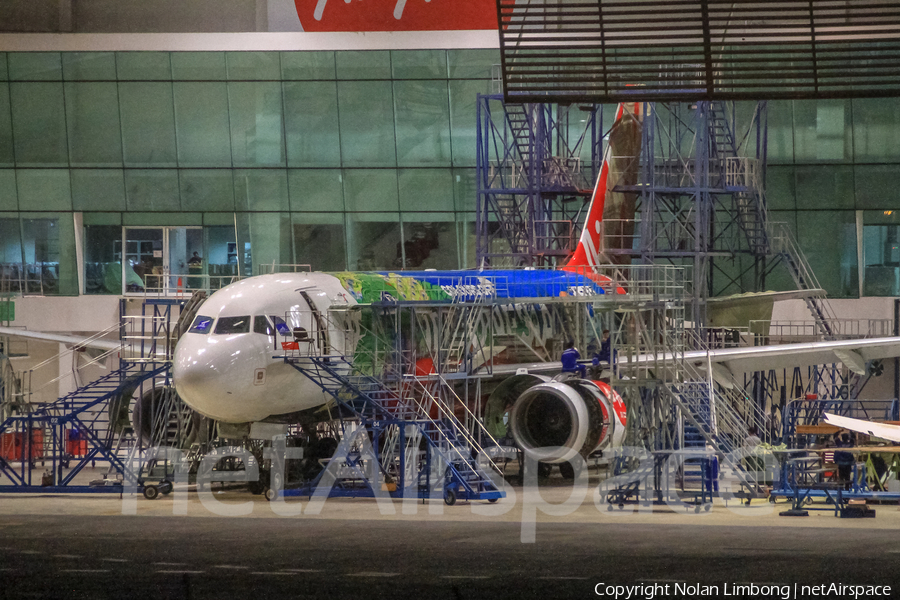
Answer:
[{"left": 0, "top": 474, "right": 900, "bottom": 599}]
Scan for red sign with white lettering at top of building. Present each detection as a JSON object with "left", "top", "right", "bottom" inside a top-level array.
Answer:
[{"left": 294, "top": 0, "right": 497, "bottom": 31}]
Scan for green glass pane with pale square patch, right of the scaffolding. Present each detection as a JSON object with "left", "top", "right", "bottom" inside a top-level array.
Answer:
[{"left": 794, "top": 100, "right": 853, "bottom": 162}]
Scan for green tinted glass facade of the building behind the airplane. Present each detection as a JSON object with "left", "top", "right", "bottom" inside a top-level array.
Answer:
[{"left": 0, "top": 50, "right": 900, "bottom": 297}]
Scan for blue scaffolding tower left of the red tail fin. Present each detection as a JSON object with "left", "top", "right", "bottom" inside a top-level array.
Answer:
[{"left": 476, "top": 94, "right": 604, "bottom": 267}]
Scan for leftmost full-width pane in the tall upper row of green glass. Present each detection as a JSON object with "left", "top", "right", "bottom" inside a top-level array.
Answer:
[{"left": 10, "top": 83, "right": 69, "bottom": 167}]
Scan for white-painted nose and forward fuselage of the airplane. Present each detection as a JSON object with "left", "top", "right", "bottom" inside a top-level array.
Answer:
[{"left": 173, "top": 273, "right": 356, "bottom": 423}]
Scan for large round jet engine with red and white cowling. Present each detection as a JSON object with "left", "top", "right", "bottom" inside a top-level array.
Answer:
[{"left": 495, "top": 375, "right": 625, "bottom": 463}]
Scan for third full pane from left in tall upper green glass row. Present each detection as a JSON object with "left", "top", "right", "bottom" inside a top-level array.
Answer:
[{"left": 119, "top": 82, "right": 176, "bottom": 167}]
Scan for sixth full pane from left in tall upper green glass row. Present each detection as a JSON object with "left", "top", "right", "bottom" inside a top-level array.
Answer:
[{"left": 284, "top": 81, "right": 341, "bottom": 167}]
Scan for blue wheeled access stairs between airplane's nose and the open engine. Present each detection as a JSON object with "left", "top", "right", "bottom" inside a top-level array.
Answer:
[{"left": 282, "top": 356, "right": 505, "bottom": 505}]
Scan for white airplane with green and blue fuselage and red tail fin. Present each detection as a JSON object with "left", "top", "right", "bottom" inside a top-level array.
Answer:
[{"left": 0, "top": 105, "right": 900, "bottom": 482}]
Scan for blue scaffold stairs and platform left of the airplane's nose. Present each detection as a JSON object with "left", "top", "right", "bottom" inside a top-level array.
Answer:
[{"left": 0, "top": 298, "right": 182, "bottom": 493}]
